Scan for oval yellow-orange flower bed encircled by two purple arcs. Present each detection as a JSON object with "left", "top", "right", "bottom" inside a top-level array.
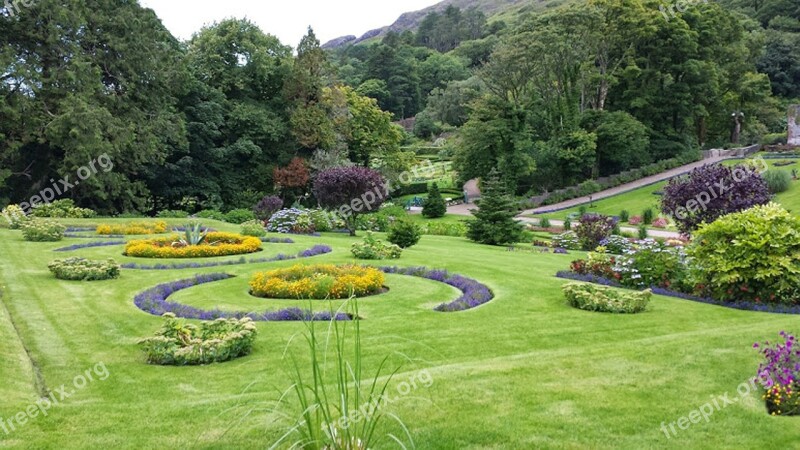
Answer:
[{"left": 250, "top": 264, "right": 385, "bottom": 299}]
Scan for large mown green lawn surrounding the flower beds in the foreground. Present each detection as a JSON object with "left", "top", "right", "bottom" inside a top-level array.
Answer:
[{"left": 0, "top": 219, "right": 800, "bottom": 449}]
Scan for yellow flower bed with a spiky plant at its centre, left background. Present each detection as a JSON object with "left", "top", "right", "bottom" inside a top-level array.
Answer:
[{"left": 125, "top": 232, "right": 261, "bottom": 258}]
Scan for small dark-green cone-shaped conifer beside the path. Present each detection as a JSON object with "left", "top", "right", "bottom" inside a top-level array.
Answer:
[{"left": 467, "top": 169, "right": 523, "bottom": 245}]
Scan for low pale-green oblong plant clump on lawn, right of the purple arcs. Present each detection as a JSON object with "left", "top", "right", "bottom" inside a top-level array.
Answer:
[{"left": 562, "top": 283, "right": 652, "bottom": 314}]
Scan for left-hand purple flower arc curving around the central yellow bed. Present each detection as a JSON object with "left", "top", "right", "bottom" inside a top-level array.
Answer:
[{"left": 133, "top": 273, "right": 353, "bottom": 322}]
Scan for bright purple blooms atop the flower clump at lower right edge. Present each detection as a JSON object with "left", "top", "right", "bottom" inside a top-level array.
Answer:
[{"left": 753, "top": 331, "right": 800, "bottom": 388}]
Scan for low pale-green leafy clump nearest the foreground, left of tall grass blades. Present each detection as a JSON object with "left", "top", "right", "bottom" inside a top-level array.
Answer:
[{"left": 139, "top": 313, "right": 258, "bottom": 366}]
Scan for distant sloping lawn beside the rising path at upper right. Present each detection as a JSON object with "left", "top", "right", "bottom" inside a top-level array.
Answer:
[{"left": 530, "top": 156, "right": 800, "bottom": 225}]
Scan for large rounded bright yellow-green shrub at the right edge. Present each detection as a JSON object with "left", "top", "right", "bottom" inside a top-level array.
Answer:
[{"left": 687, "top": 203, "right": 800, "bottom": 304}]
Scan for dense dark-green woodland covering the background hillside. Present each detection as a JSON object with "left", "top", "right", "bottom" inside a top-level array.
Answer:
[{"left": 0, "top": 0, "right": 800, "bottom": 213}]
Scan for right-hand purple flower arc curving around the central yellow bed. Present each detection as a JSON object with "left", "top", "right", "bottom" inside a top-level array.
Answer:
[{"left": 380, "top": 266, "right": 494, "bottom": 312}]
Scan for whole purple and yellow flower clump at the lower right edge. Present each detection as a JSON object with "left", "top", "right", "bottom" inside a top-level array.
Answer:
[{"left": 753, "top": 331, "right": 800, "bottom": 416}]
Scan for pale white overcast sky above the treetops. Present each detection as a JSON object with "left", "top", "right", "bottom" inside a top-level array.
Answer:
[{"left": 140, "top": 0, "right": 439, "bottom": 47}]
